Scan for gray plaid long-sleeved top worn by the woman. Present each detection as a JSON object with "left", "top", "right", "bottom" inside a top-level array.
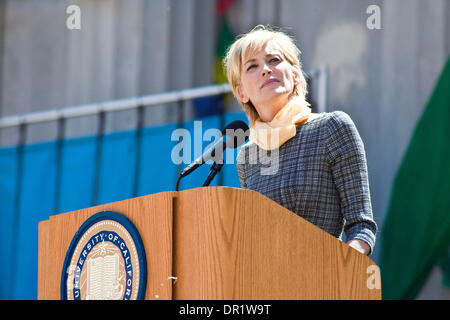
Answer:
[{"left": 236, "top": 111, "right": 377, "bottom": 253}]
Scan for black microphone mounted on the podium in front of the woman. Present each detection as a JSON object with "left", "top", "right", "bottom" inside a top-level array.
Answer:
[{"left": 180, "top": 120, "right": 249, "bottom": 178}]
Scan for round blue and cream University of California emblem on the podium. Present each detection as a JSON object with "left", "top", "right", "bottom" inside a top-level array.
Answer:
[{"left": 61, "top": 211, "right": 147, "bottom": 300}]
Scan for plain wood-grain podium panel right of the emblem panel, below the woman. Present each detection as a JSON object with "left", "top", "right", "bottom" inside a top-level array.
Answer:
[{"left": 173, "top": 187, "right": 381, "bottom": 299}]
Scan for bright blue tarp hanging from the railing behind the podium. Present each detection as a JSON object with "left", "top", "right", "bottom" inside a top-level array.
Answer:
[{"left": 0, "top": 112, "right": 246, "bottom": 299}]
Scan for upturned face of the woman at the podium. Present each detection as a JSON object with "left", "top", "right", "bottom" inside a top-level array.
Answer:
[{"left": 236, "top": 41, "right": 299, "bottom": 121}]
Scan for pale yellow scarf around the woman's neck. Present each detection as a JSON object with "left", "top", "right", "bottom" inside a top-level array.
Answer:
[{"left": 249, "top": 97, "right": 311, "bottom": 150}]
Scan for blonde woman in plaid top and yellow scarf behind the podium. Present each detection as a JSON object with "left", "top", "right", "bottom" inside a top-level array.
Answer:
[{"left": 224, "top": 26, "right": 377, "bottom": 255}]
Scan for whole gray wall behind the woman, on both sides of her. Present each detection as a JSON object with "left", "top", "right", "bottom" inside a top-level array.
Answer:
[{"left": 0, "top": 0, "right": 450, "bottom": 297}]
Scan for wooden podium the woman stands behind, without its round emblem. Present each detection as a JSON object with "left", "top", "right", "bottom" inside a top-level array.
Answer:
[{"left": 38, "top": 187, "right": 381, "bottom": 300}]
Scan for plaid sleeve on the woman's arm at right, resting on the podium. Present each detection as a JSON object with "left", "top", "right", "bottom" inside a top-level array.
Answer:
[{"left": 327, "top": 111, "right": 377, "bottom": 253}]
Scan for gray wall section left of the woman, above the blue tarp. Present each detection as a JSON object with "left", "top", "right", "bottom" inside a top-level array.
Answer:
[{"left": 0, "top": 0, "right": 220, "bottom": 145}]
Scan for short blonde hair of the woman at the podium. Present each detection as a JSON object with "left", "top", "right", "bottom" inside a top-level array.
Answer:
[{"left": 223, "top": 25, "right": 309, "bottom": 124}]
